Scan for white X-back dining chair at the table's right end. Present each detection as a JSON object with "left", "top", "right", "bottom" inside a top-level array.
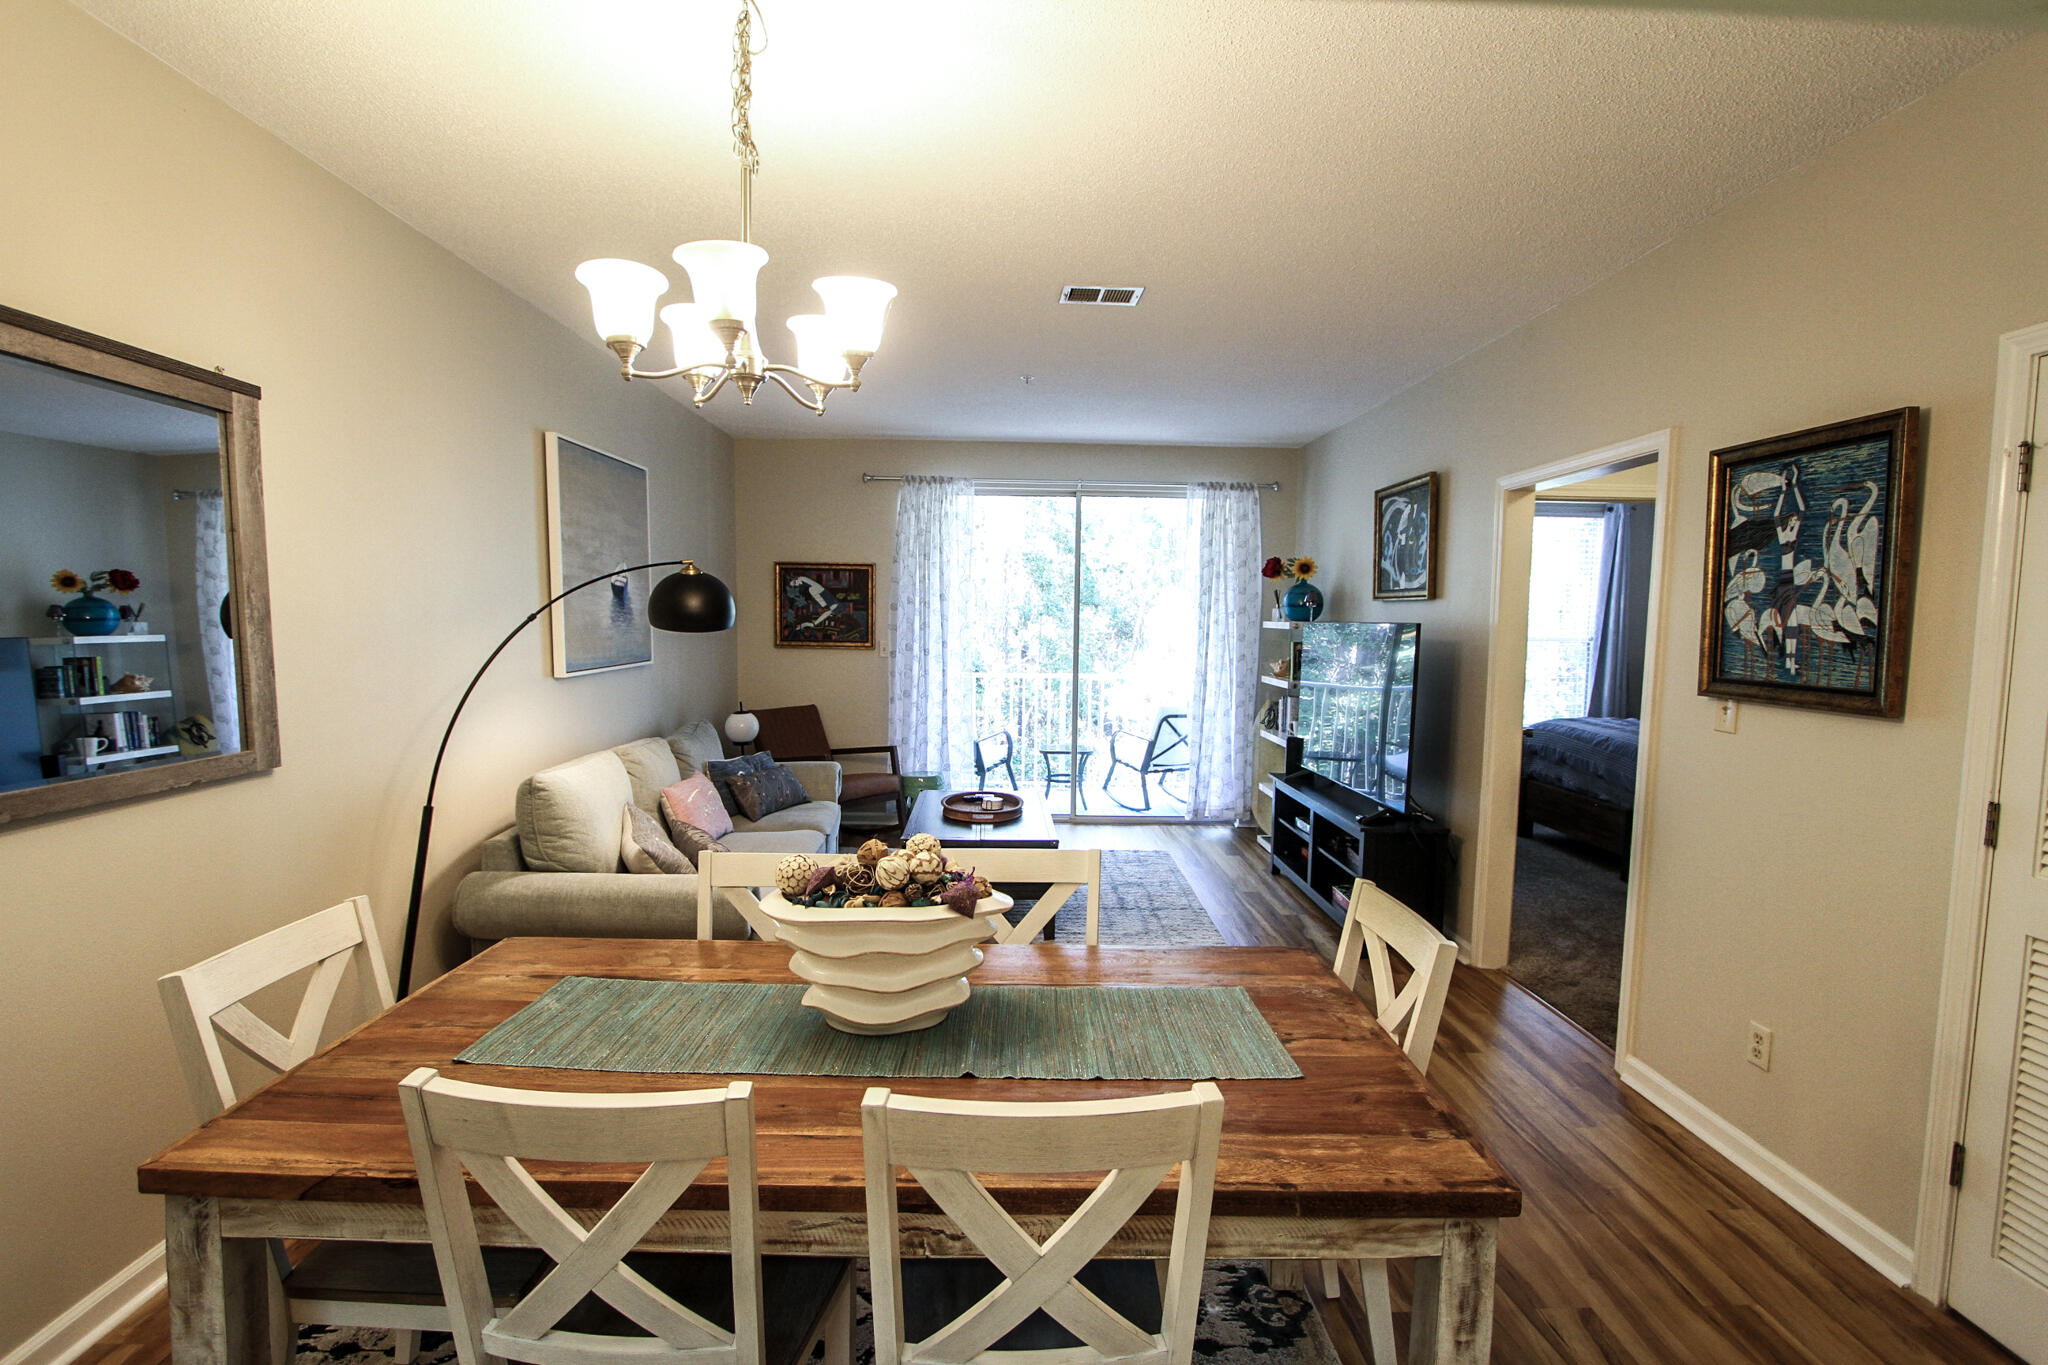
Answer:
[{"left": 1323, "top": 878, "right": 1458, "bottom": 1365}]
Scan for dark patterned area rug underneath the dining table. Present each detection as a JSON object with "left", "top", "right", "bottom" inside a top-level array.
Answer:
[{"left": 297, "top": 1261, "right": 1337, "bottom": 1365}]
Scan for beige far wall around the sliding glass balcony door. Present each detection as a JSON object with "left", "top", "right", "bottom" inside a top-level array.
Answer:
[{"left": 733, "top": 439, "right": 1309, "bottom": 745}]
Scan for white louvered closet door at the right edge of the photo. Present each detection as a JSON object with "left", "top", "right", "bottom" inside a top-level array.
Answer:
[{"left": 1950, "top": 360, "right": 2048, "bottom": 1365}]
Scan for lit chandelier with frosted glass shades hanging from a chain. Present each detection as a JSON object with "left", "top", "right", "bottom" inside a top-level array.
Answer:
[{"left": 575, "top": 0, "right": 897, "bottom": 415}]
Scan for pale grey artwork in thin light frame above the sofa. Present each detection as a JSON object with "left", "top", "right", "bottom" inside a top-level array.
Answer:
[{"left": 547, "top": 432, "right": 653, "bottom": 677}]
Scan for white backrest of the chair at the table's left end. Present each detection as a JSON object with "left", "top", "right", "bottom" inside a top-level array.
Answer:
[{"left": 156, "top": 896, "right": 391, "bottom": 1119}]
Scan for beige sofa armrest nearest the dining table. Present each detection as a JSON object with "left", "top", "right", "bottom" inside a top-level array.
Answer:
[{"left": 455, "top": 872, "right": 748, "bottom": 943}]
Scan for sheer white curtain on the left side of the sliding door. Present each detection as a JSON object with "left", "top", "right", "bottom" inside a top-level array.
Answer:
[{"left": 889, "top": 475, "right": 975, "bottom": 776}]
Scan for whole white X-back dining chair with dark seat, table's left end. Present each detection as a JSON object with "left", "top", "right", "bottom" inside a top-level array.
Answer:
[{"left": 156, "top": 896, "right": 541, "bottom": 1361}]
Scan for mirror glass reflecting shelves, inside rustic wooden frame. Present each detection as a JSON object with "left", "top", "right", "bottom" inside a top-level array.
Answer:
[{"left": 0, "top": 356, "right": 242, "bottom": 792}]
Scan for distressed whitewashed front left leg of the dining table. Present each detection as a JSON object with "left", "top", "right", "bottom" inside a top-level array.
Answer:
[{"left": 164, "top": 1195, "right": 274, "bottom": 1365}]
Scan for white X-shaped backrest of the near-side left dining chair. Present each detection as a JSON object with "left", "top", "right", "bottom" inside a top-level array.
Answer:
[{"left": 399, "top": 1066, "right": 762, "bottom": 1365}]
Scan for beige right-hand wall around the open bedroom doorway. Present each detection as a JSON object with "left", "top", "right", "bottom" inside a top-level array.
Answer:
[{"left": 1303, "top": 37, "right": 2048, "bottom": 1240}]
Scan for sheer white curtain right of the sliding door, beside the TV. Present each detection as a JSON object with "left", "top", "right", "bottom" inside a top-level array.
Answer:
[{"left": 1188, "top": 483, "right": 1262, "bottom": 821}]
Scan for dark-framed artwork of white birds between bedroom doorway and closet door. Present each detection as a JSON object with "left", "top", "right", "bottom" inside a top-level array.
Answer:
[{"left": 1700, "top": 407, "right": 1921, "bottom": 720}]
